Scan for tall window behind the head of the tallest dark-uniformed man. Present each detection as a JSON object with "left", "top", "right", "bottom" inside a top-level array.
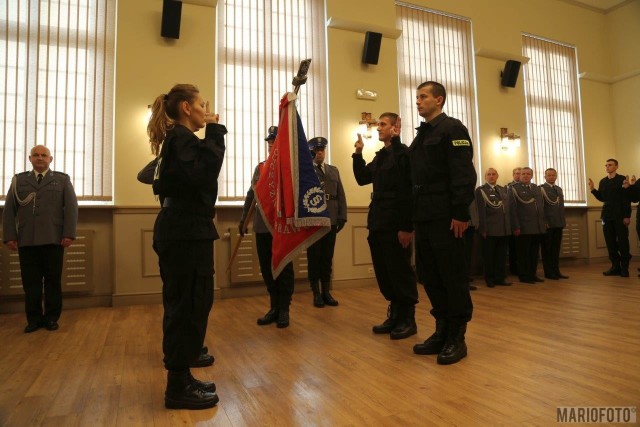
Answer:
[{"left": 396, "top": 2, "right": 479, "bottom": 162}]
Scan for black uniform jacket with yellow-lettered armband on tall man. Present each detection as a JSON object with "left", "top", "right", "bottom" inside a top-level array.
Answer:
[{"left": 409, "top": 113, "right": 477, "bottom": 222}]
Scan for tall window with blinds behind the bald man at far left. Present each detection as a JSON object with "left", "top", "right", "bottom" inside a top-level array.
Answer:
[{"left": 0, "top": 0, "right": 116, "bottom": 201}]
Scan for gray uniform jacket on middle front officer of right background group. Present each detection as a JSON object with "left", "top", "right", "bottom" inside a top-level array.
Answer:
[{"left": 509, "top": 182, "right": 546, "bottom": 234}]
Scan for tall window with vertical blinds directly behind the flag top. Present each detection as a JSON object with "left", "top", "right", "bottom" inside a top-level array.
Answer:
[{"left": 217, "top": 0, "right": 328, "bottom": 201}]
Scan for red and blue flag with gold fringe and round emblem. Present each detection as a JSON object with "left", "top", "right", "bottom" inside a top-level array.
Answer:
[{"left": 254, "top": 92, "right": 331, "bottom": 277}]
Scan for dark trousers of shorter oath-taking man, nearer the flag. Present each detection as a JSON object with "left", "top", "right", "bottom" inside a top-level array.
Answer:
[{"left": 367, "top": 230, "right": 418, "bottom": 305}]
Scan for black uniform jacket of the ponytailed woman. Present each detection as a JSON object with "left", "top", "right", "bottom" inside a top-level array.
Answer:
[{"left": 153, "top": 123, "right": 227, "bottom": 241}]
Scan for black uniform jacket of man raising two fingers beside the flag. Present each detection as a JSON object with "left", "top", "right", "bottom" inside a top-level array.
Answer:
[{"left": 351, "top": 137, "right": 413, "bottom": 232}]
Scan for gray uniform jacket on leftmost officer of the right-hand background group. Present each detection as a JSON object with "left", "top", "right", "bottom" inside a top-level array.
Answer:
[{"left": 475, "top": 184, "right": 511, "bottom": 237}]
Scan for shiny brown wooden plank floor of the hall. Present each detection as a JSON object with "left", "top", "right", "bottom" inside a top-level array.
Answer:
[{"left": 0, "top": 264, "right": 640, "bottom": 426}]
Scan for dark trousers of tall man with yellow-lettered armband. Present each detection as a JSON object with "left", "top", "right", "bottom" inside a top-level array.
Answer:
[{"left": 415, "top": 219, "right": 473, "bottom": 324}]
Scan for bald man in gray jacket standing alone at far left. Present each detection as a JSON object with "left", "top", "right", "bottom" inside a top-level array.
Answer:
[{"left": 2, "top": 145, "right": 78, "bottom": 333}]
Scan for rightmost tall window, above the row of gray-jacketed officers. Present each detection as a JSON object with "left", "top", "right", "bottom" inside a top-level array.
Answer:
[{"left": 522, "top": 34, "right": 586, "bottom": 204}]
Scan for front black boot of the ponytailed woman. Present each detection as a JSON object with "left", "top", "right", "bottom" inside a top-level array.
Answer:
[{"left": 164, "top": 370, "right": 220, "bottom": 409}]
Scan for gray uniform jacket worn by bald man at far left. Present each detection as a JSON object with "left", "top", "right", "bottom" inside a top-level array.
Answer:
[{"left": 2, "top": 170, "right": 78, "bottom": 247}]
